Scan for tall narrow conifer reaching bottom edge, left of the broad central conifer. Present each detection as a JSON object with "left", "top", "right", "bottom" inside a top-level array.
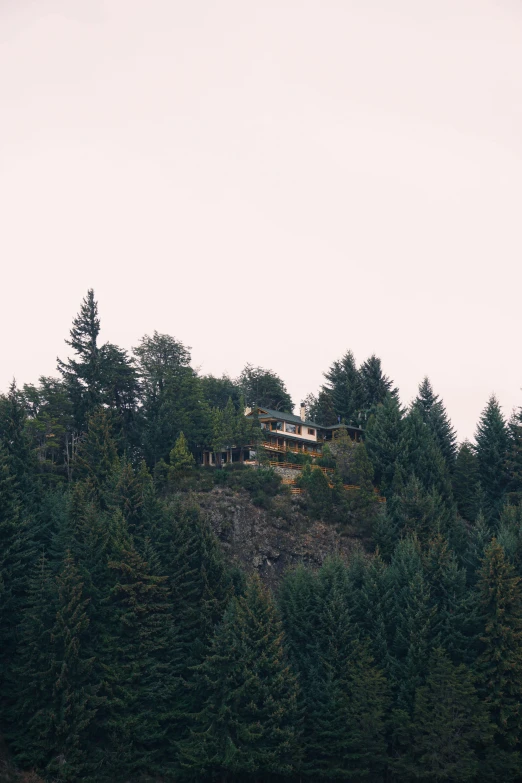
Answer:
[{"left": 99, "top": 544, "right": 177, "bottom": 780}]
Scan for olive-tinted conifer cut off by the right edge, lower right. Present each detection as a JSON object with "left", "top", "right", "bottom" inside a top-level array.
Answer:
[{"left": 476, "top": 539, "right": 522, "bottom": 752}]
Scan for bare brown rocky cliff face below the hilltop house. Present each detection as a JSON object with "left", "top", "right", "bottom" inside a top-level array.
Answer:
[{"left": 193, "top": 489, "right": 355, "bottom": 586}]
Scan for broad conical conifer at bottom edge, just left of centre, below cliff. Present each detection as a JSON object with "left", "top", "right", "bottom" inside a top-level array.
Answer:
[{"left": 180, "top": 577, "right": 299, "bottom": 783}]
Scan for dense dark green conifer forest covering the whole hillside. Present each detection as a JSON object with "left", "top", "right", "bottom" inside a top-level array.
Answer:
[{"left": 0, "top": 290, "right": 522, "bottom": 783}]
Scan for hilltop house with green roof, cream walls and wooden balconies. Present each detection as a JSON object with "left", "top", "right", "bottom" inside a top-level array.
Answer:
[{"left": 202, "top": 403, "right": 363, "bottom": 465}]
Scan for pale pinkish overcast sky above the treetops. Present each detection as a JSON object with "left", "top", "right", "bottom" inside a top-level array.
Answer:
[{"left": 0, "top": 0, "right": 522, "bottom": 438}]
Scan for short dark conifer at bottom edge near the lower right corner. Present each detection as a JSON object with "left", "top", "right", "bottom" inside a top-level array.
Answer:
[{"left": 393, "top": 648, "right": 492, "bottom": 783}]
